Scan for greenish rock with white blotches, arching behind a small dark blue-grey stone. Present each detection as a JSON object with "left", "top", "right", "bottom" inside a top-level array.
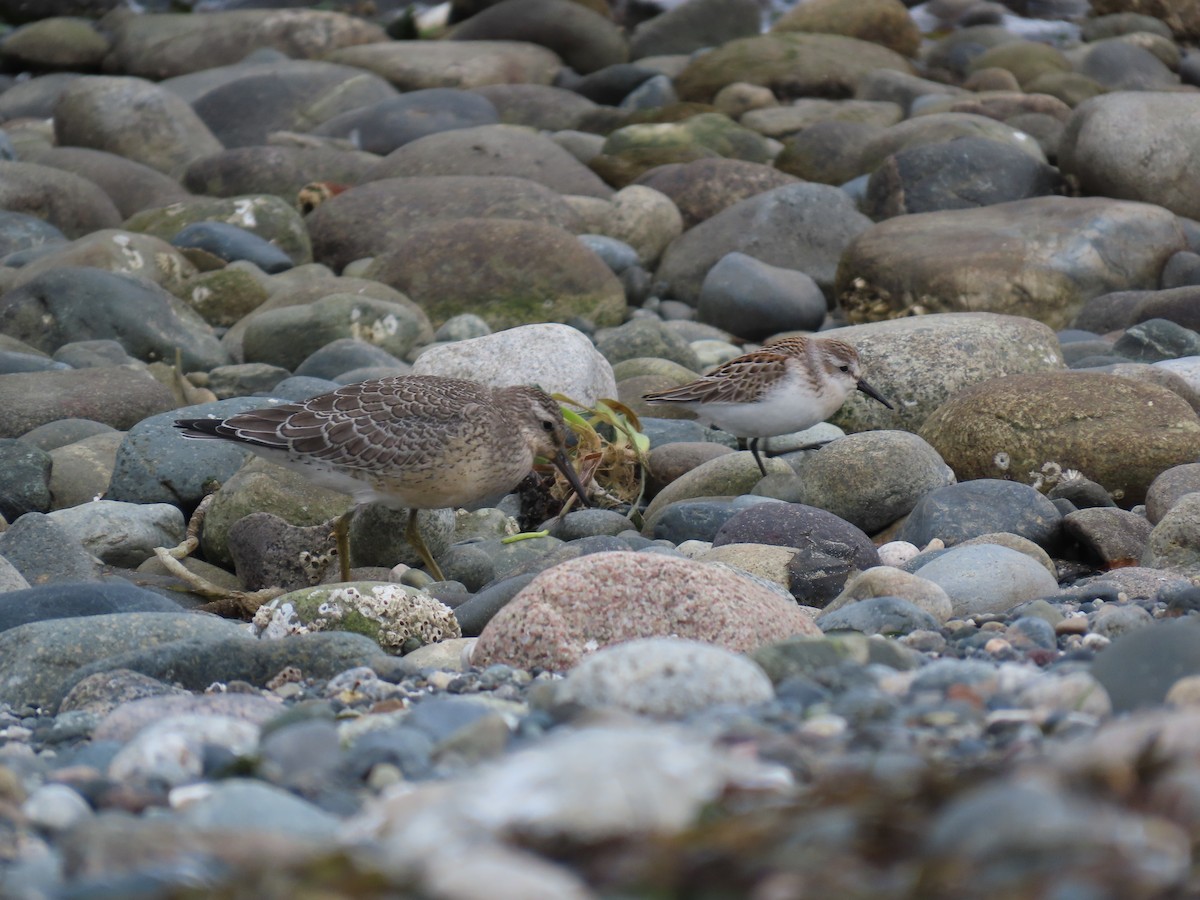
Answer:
[{"left": 122, "top": 193, "right": 312, "bottom": 265}]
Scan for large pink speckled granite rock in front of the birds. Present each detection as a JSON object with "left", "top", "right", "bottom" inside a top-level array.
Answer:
[{"left": 472, "top": 551, "right": 821, "bottom": 670}]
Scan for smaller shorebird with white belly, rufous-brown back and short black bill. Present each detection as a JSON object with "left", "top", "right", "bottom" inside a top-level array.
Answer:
[{"left": 642, "top": 337, "right": 893, "bottom": 476}]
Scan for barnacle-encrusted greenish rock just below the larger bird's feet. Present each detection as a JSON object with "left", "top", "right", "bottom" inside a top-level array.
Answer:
[{"left": 251, "top": 581, "right": 462, "bottom": 653}]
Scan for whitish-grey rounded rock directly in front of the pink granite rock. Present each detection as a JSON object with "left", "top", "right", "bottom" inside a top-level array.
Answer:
[{"left": 558, "top": 637, "right": 775, "bottom": 719}]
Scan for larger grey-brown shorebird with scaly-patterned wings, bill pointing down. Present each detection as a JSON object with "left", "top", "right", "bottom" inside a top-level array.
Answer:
[{"left": 175, "top": 376, "right": 587, "bottom": 581}]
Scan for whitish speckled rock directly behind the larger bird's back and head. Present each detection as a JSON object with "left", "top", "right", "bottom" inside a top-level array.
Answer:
[{"left": 413, "top": 322, "right": 617, "bottom": 406}]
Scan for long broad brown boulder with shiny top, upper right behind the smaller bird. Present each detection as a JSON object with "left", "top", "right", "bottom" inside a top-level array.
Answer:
[{"left": 835, "top": 197, "right": 1186, "bottom": 328}]
